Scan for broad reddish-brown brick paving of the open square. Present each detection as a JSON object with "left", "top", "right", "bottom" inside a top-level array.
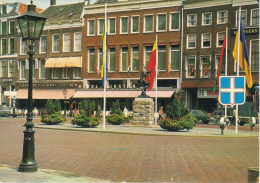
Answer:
[{"left": 0, "top": 118, "right": 259, "bottom": 182}]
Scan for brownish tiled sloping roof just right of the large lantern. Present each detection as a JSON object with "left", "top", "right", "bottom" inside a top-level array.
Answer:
[{"left": 41, "top": 2, "right": 85, "bottom": 22}]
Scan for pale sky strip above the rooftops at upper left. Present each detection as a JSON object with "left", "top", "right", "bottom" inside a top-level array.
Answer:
[{"left": 6, "top": 0, "right": 96, "bottom": 9}]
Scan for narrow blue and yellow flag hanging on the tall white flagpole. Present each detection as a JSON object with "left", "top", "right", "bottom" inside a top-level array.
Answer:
[{"left": 101, "top": 25, "right": 107, "bottom": 87}]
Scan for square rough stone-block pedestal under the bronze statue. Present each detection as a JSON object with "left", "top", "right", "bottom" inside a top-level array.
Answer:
[{"left": 133, "top": 97, "right": 154, "bottom": 125}]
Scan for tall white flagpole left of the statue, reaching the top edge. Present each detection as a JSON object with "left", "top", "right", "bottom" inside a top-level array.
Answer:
[{"left": 103, "top": 1, "right": 107, "bottom": 130}]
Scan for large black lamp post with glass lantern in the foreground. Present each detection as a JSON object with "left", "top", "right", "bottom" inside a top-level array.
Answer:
[{"left": 17, "top": 0, "right": 47, "bottom": 172}]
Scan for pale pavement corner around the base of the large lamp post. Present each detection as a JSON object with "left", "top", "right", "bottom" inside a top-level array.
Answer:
[{"left": 0, "top": 164, "right": 105, "bottom": 183}]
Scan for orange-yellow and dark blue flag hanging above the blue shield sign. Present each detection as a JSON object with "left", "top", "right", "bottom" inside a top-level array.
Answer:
[{"left": 233, "top": 18, "right": 253, "bottom": 88}]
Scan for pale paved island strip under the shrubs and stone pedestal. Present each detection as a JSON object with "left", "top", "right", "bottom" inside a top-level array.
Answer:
[{"left": 31, "top": 122, "right": 259, "bottom": 137}]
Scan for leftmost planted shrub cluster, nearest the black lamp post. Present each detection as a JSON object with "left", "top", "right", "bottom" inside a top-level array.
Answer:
[{"left": 40, "top": 99, "right": 66, "bottom": 125}]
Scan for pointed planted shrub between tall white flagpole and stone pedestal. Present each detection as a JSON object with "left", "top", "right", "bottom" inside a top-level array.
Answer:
[{"left": 106, "top": 99, "right": 130, "bottom": 125}]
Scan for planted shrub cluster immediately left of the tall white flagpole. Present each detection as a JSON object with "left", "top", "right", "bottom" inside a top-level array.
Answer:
[{"left": 71, "top": 99, "right": 100, "bottom": 128}]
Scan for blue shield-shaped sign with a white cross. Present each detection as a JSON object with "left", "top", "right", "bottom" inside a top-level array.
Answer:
[{"left": 219, "top": 76, "right": 246, "bottom": 106}]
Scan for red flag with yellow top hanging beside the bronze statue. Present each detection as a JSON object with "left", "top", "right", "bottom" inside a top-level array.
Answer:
[{"left": 146, "top": 40, "right": 157, "bottom": 91}]
